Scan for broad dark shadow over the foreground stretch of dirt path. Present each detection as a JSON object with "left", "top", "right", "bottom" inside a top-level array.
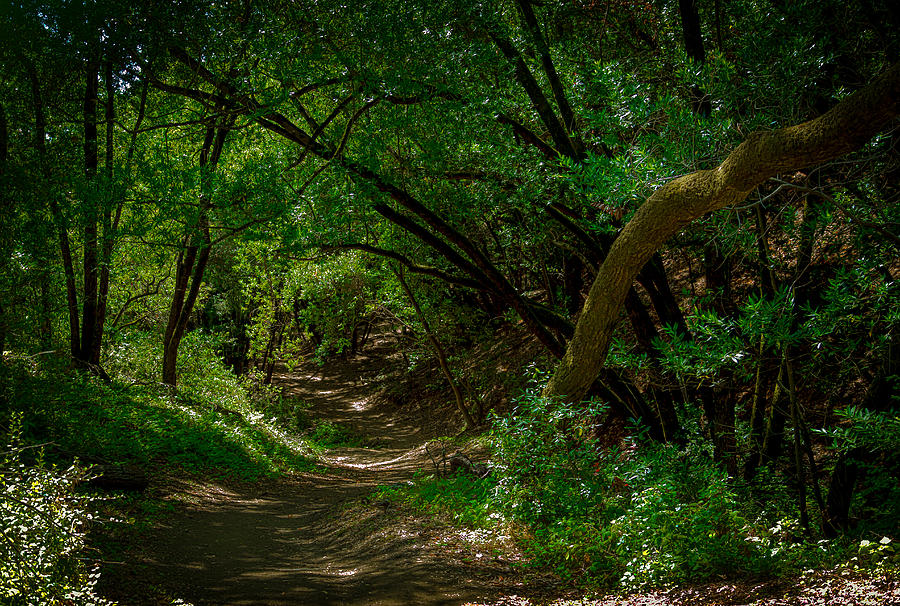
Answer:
[{"left": 130, "top": 476, "right": 505, "bottom": 605}]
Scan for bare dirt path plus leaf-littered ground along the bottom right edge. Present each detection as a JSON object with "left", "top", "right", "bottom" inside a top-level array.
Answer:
[{"left": 101, "top": 344, "right": 900, "bottom": 606}]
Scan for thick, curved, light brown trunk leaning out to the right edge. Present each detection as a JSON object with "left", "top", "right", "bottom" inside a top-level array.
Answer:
[{"left": 544, "top": 63, "right": 900, "bottom": 400}]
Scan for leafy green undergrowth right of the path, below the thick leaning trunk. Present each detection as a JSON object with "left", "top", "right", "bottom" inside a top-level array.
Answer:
[{"left": 381, "top": 393, "right": 898, "bottom": 590}]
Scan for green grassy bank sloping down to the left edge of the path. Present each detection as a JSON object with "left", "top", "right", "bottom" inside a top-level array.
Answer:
[{"left": 0, "top": 330, "right": 314, "bottom": 480}]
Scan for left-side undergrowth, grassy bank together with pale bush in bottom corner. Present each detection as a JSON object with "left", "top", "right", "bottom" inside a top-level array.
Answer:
[{"left": 0, "top": 332, "right": 327, "bottom": 606}]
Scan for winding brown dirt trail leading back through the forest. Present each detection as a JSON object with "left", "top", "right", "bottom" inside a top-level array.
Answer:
[{"left": 114, "top": 343, "right": 536, "bottom": 606}]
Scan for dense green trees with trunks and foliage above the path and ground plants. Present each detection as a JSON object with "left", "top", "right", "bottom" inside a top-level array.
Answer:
[{"left": 0, "top": 0, "right": 900, "bottom": 600}]
